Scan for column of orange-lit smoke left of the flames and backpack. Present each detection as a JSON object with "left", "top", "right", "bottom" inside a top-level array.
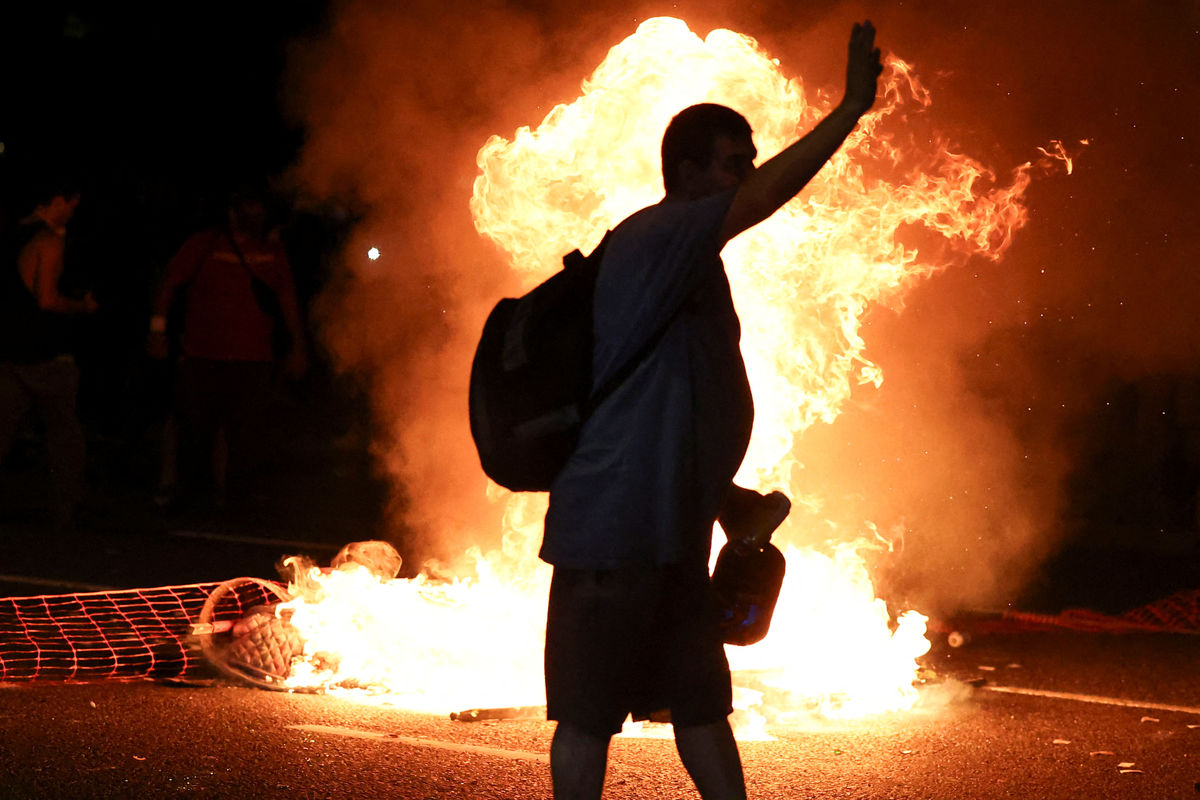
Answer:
[{"left": 279, "top": 1, "right": 624, "bottom": 563}]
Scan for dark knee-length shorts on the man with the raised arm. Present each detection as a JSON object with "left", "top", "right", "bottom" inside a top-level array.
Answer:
[{"left": 546, "top": 566, "right": 733, "bottom": 736}]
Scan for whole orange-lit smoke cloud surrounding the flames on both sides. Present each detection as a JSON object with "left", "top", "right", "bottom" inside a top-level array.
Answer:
[{"left": 288, "top": 0, "right": 1200, "bottom": 609}]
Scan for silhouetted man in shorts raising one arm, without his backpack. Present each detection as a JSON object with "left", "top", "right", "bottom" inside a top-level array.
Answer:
[{"left": 540, "top": 22, "right": 882, "bottom": 800}]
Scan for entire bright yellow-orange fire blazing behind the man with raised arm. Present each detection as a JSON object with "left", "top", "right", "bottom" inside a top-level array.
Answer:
[{"left": 272, "top": 18, "right": 1067, "bottom": 736}]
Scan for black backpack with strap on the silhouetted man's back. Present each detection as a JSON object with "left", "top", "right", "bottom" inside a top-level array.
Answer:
[{"left": 470, "top": 234, "right": 678, "bottom": 492}]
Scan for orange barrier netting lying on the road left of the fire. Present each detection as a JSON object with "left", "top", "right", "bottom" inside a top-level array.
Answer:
[{"left": 0, "top": 583, "right": 277, "bottom": 680}]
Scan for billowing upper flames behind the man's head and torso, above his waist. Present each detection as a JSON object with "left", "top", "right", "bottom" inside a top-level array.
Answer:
[{"left": 470, "top": 18, "right": 1030, "bottom": 491}]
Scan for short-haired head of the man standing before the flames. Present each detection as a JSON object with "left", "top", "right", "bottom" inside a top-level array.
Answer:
[{"left": 662, "top": 103, "right": 758, "bottom": 199}]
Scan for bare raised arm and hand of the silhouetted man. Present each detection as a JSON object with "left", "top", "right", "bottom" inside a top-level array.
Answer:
[{"left": 721, "top": 20, "right": 883, "bottom": 242}]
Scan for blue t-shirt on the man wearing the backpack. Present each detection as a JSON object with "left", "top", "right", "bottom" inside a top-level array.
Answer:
[{"left": 540, "top": 192, "right": 754, "bottom": 569}]
